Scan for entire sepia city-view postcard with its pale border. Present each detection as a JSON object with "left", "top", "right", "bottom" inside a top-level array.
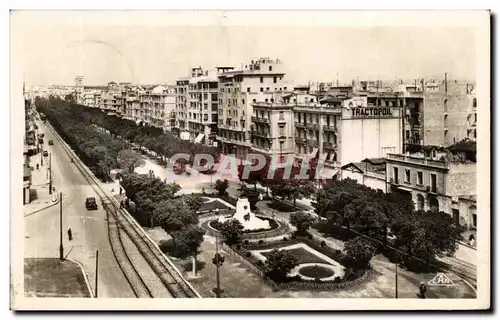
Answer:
[{"left": 10, "top": 10, "right": 491, "bottom": 310}]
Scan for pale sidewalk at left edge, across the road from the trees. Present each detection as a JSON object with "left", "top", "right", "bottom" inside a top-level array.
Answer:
[{"left": 23, "top": 154, "right": 59, "bottom": 216}]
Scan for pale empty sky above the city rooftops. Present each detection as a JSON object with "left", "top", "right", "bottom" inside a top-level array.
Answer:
[{"left": 12, "top": 13, "right": 476, "bottom": 86}]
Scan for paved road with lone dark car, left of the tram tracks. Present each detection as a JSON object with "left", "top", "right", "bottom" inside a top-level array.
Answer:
[{"left": 25, "top": 121, "right": 134, "bottom": 298}]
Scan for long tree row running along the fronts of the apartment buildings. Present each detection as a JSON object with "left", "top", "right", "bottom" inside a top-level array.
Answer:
[{"left": 64, "top": 100, "right": 220, "bottom": 164}]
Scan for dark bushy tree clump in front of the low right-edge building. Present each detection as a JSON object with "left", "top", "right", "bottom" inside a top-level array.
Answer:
[{"left": 313, "top": 179, "right": 463, "bottom": 267}]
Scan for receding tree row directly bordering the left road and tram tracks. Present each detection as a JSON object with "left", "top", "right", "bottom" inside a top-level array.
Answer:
[{"left": 35, "top": 97, "right": 126, "bottom": 180}]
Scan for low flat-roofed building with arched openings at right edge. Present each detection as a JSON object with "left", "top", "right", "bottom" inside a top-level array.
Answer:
[{"left": 386, "top": 141, "right": 477, "bottom": 228}]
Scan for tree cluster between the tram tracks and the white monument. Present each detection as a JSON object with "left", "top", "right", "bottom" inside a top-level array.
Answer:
[{"left": 121, "top": 173, "right": 205, "bottom": 273}]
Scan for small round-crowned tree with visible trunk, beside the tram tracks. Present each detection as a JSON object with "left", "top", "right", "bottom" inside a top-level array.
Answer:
[{"left": 173, "top": 224, "right": 205, "bottom": 276}]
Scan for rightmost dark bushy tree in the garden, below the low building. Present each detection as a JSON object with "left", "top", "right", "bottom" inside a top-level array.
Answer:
[{"left": 391, "top": 211, "right": 463, "bottom": 262}]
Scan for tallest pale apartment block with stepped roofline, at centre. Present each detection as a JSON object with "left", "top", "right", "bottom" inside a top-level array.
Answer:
[{"left": 217, "top": 58, "right": 291, "bottom": 159}]
